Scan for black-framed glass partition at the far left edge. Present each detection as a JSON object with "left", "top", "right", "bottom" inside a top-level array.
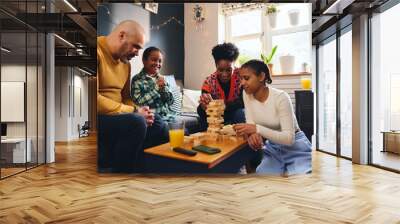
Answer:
[{"left": 0, "top": 0, "right": 46, "bottom": 179}]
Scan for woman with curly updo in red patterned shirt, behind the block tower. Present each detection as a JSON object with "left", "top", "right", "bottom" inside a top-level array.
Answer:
[{"left": 197, "top": 43, "right": 245, "bottom": 131}]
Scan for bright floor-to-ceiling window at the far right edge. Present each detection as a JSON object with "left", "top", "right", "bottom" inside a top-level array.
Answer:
[{"left": 370, "top": 1, "right": 400, "bottom": 170}]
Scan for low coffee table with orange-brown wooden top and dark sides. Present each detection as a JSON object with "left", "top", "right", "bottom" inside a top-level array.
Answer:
[{"left": 144, "top": 137, "right": 255, "bottom": 173}]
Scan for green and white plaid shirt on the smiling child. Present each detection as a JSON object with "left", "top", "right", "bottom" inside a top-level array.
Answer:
[{"left": 131, "top": 69, "right": 177, "bottom": 121}]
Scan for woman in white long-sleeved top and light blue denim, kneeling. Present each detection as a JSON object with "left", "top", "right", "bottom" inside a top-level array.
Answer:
[{"left": 234, "top": 60, "right": 311, "bottom": 175}]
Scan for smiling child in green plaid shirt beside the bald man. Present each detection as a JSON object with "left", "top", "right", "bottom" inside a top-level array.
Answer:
[{"left": 131, "top": 47, "right": 177, "bottom": 121}]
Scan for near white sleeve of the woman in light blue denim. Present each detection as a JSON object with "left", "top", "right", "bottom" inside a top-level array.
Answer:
[{"left": 257, "top": 92, "right": 295, "bottom": 145}]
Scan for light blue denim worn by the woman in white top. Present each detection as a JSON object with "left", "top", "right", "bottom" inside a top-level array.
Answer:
[{"left": 256, "top": 131, "right": 312, "bottom": 175}]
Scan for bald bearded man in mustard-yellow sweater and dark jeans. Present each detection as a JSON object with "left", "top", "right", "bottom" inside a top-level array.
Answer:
[{"left": 97, "top": 20, "right": 168, "bottom": 172}]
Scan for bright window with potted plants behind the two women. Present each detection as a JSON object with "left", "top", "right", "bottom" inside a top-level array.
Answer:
[{"left": 226, "top": 3, "right": 311, "bottom": 74}]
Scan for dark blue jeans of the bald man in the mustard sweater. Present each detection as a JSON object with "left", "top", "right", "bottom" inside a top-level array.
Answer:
[{"left": 97, "top": 113, "right": 169, "bottom": 173}]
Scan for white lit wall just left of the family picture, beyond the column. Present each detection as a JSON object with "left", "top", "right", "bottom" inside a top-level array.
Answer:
[{"left": 55, "top": 67, "right": 89, "bottom": 141}]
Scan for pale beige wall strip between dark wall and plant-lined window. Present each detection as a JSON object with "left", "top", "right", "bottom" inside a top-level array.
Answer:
[{"left": 184, "top": 3, "right": 223, "bottom": 89}]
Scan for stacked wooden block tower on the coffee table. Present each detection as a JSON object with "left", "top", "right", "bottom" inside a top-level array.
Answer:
[{"left": 206, "top": 100, "right": 225, "bottom": 133}]
